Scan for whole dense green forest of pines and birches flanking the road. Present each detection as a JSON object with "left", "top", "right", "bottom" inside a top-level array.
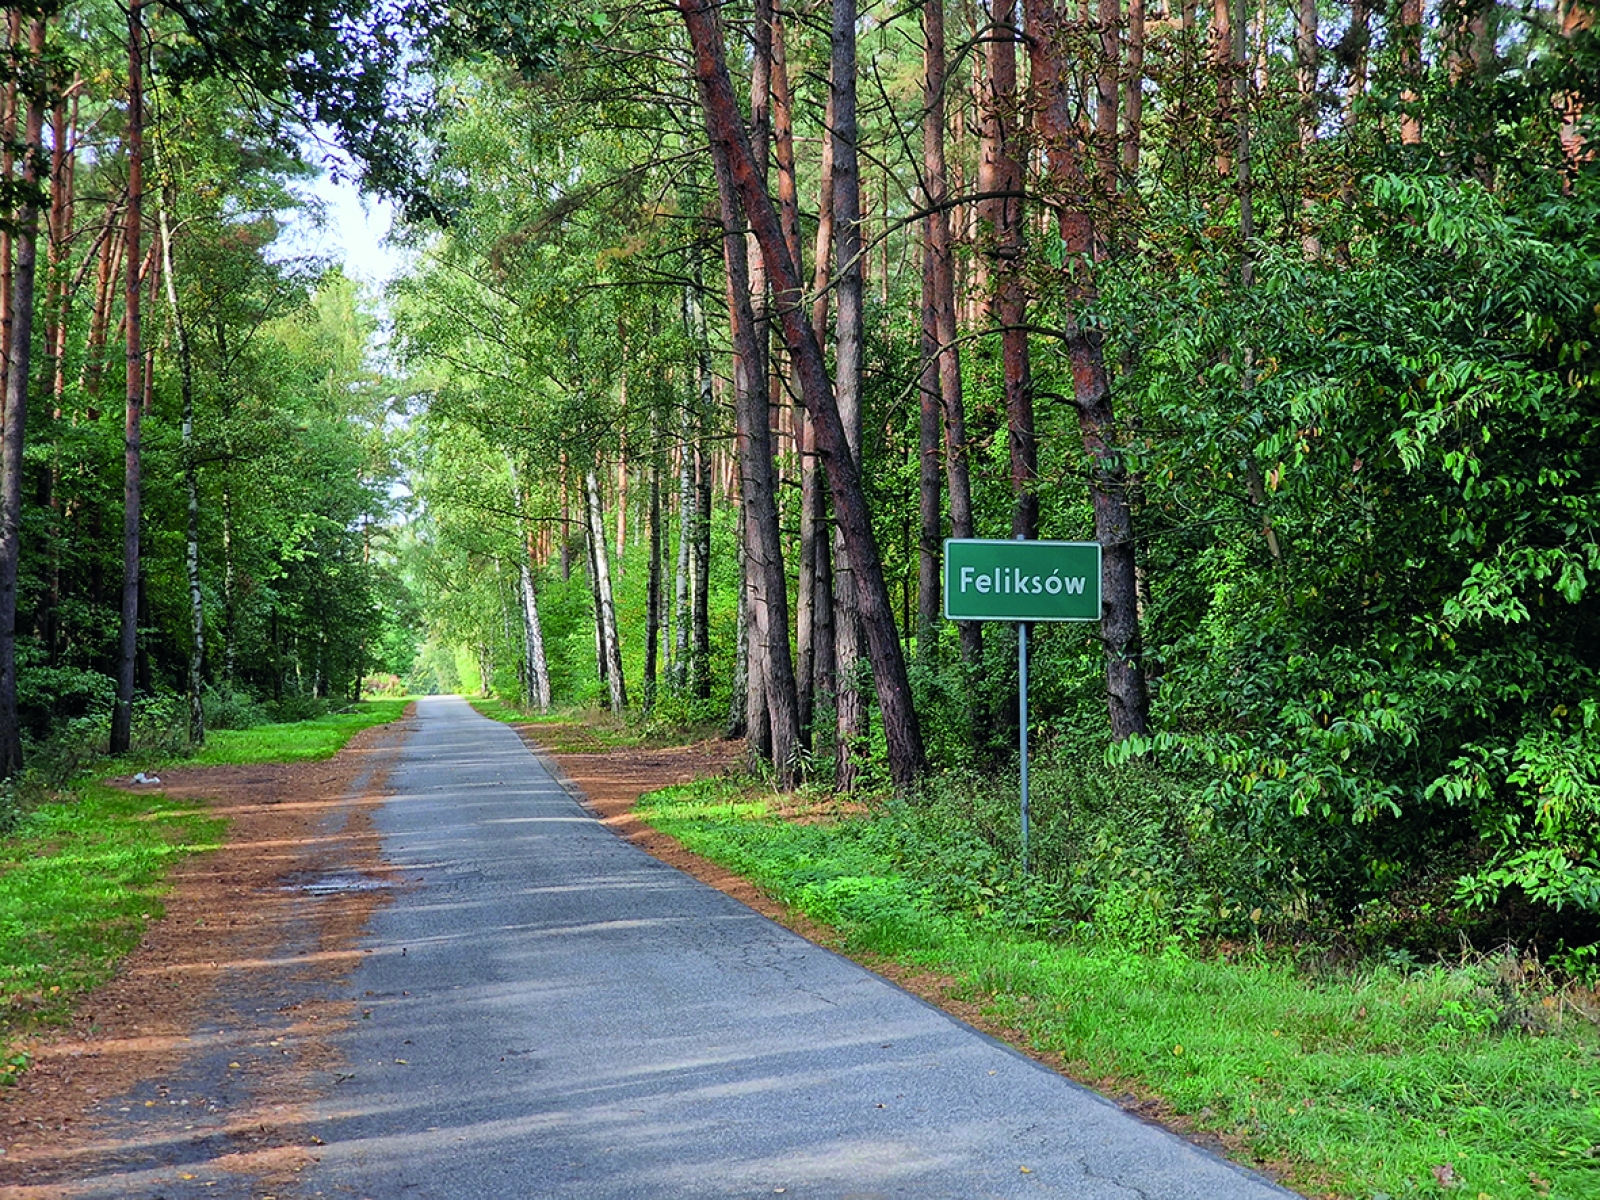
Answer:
[{"left": 0, "top": 0, "right": 1600, "bottom": 962}]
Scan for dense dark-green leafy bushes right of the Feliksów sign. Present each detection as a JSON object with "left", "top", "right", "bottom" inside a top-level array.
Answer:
[{"left": 1109, "top": 167, "right": 1600, "bottom": 912}]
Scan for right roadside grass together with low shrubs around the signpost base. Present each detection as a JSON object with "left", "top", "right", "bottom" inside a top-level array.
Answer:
[{"left": 640, "top": 768, "right": 1600, "bottom": 1200}]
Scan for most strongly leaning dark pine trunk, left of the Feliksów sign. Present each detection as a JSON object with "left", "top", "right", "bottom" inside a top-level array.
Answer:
[{"left": 680, "top": 0, "right": 925, "bottom": 787}]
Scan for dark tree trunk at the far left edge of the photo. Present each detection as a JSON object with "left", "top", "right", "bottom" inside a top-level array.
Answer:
[{"left": 0, "top": 19, "right": 45, "bottom": 779}]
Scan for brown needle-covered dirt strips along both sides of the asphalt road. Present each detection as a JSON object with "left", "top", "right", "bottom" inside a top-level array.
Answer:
[{"left": 0, "top": 720, "right": 1267, "bottom": 1200}]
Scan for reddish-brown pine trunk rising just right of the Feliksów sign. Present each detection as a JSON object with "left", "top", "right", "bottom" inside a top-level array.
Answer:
[{"left": 1027, "top": 0, "right": 1149, "bottom": 741}]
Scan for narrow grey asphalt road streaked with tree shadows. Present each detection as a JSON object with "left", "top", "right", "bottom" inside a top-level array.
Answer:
[{"left": 299, "top": 698, "right": 1290, "bottom": 1200}]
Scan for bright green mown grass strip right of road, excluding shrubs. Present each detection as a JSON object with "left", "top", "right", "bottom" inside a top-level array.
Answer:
[{"left": 642, "top": 781, "right": 1600, "bottom": 1200}]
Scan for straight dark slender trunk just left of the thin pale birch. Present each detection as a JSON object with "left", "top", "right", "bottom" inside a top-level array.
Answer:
[{"left": 110, "top": 0, "right": 144, "bottom": 754}]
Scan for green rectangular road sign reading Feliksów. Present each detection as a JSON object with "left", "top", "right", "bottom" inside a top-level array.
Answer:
[{"left": 944, "top": 538, "right": 1101, "bottom": 621}]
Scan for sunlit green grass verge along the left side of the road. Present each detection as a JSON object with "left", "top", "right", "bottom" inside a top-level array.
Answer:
[{"left": 0, "top": 701, "right": 408, "bottom": 1086}]
